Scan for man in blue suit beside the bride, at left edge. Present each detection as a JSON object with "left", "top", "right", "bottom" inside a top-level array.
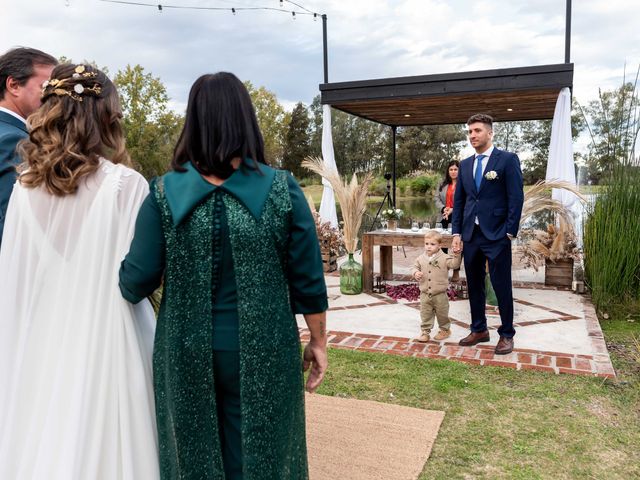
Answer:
[{"left": 0, "top": 47, "right": 58, "bottom": 242}]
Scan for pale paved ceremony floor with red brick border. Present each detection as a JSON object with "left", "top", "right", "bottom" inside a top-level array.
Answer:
[{"left": 298, "top": 249, "right": 615, "bottom": 377}]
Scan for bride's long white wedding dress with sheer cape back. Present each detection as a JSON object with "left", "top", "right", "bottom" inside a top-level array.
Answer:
[{"left": 0, "top": 159, "right": 159, "bottom": 480}]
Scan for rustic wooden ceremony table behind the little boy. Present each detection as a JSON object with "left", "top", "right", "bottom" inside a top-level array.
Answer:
[{"left": 362, "top": 229, "right": 453, "bottom": 293}]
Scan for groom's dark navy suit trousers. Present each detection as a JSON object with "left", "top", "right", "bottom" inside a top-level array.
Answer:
[{"left": 464, "top": 225, "right": 516, "bottom": 338}]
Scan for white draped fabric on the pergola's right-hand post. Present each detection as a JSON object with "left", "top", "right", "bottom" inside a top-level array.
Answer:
[{"left": 546, "top": 87, "right": 577, "bottom": 207}]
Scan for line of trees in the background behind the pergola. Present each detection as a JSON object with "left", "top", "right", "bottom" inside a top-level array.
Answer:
[{"left": 114, "top": 65, "right": 640, "bottom": 184}]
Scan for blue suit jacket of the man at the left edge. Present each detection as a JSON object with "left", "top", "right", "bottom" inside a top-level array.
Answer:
[{"left": 0, "top": 111, "right": 28, "bottom": 242}]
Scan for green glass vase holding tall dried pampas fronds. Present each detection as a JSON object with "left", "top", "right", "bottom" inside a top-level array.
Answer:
[{"left": 302, "top": 157, "right": 373, "bottom": 295}]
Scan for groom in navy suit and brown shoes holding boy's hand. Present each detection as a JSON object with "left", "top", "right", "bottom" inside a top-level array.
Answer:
[{"left": 452, "top": 114, "right": 524, "bottom": 355}]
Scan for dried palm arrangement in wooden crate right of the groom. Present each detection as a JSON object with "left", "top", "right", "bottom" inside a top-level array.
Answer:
[{"left": 518, "top": 180, "right": 586, "bottom": 287}]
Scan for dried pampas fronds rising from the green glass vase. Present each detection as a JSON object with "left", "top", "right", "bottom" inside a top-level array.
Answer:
[{"left": 302, "top": 157, "right": 373, "bottom": 253}]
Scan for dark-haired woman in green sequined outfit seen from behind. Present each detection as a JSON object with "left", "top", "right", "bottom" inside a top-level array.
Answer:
[{"left": 120, "top": 73, "right": 327, "bottom": 480}]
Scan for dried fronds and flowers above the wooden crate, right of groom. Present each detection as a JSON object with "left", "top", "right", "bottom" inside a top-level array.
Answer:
[{"left": 518, "top": 180, "right": 586, "bottom": 271}]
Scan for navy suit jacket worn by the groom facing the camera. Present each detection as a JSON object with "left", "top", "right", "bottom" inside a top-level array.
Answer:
[{"left": 451, "top": 148, "right": 524, "bottom": 241}]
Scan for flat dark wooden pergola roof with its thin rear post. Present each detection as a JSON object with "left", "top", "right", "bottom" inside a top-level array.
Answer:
[{"left": 320, "top": 63, "right": 573, "bottom": 205}]
